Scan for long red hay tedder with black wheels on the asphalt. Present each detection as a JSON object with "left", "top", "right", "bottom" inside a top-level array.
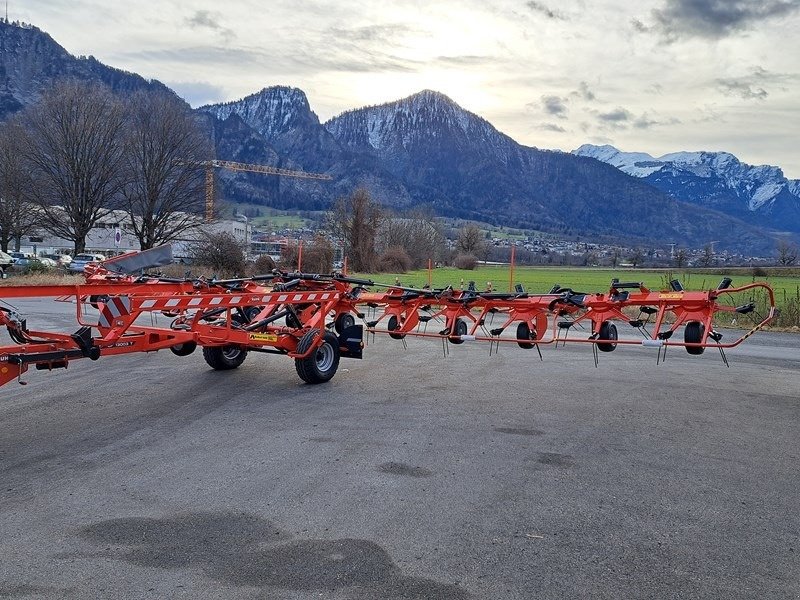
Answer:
[{"left": 0, "top": 247, "right": 776, "bottom": 385}]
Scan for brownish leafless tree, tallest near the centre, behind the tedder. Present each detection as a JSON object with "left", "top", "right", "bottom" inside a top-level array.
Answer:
[{"left": 329, "top": 188, "right": 382, "bottom": 272}]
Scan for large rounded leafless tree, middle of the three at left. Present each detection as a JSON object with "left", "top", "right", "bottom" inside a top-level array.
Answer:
[{"left": 22, "top": 82, "right": 125, "bottom": 253}]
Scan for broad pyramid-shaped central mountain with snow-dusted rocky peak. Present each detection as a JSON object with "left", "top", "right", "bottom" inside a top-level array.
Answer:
[{"left": 325, "top": 90, "right": 776, "bottom": 251}]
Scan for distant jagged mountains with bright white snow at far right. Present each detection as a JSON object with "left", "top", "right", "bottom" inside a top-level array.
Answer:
[{"left": 573, "top": 144, "right": 800, "bottom": 232}]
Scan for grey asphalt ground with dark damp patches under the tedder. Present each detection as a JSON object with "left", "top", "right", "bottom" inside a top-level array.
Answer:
[{"left": 0, "top": 301, "right": 800, "bottom": 600}]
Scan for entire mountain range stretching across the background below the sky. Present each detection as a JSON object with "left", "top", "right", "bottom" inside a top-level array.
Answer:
[{"left": 0, "top": 22, "right": 800, "bottom": 254}]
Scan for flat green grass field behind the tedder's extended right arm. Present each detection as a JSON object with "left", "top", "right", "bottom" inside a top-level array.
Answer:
[{"left": 358, "top": 266, "right": 800, "bottom": 328}]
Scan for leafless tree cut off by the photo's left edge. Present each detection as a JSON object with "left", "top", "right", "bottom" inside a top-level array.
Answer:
[{"left": 0, "top": 121, "right": 41, "bottom": 252}]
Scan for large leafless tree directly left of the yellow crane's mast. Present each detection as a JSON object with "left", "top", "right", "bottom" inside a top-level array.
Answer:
[{"left": 123, "top": 92, "right": 211, "bottom": 250}]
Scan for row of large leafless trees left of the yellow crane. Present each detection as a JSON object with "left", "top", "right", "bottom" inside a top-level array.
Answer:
[{"left": 0, "top": 81, "right": 213, "bottom": 254}]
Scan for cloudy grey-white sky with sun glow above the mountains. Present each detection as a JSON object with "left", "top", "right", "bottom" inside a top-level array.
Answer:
[{"left": 21, "top": 0, "right": 800, "bottom": 178}]
